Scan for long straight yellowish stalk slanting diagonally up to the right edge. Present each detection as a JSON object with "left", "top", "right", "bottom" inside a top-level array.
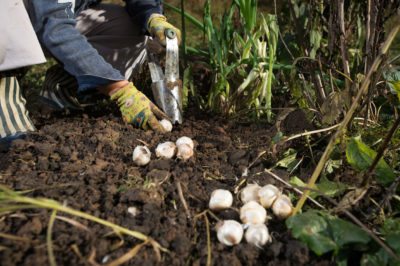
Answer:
[{"left": 293, "top": 15, "right": 400, "bottom": 215}]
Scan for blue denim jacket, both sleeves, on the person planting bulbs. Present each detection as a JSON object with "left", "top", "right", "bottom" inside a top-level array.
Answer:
[{"left": 26, "top": 0, "right": 162, "bottom": 92}]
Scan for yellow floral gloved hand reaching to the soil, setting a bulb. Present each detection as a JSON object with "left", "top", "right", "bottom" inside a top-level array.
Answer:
[{"left": 111, "top": 82, "right": 169, "bottom": 133}]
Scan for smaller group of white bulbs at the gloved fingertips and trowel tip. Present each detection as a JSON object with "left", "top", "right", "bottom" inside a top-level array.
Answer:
[{"left": 132, "top": 120, "right": 194, "bottom": 166}]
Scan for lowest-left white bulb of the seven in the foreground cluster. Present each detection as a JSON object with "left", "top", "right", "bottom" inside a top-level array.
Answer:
[{"left": 217, "top": 220, "right": 243, "bottom": 246}]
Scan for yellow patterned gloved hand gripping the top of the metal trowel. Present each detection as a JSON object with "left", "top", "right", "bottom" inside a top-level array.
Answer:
[{"left": 147, "top": 14, "right": 181, "bottom": 46}]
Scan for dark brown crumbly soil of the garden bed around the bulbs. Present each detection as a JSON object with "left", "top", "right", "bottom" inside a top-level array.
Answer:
[{"left": 0, "top": 105, "right": 328, "bottom": 266}]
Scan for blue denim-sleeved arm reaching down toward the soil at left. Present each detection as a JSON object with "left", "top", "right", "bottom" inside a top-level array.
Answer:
[{"left": 28, "top": 0, "right": 125, "bottom": 90}]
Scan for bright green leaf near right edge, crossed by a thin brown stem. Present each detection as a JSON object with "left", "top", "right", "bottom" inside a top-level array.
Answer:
[{"left": 346, "top": 137, "right": 396, "bottom": 185}]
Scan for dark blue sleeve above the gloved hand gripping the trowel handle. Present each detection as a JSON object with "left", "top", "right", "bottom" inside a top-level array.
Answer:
[{"left": 125, "top": 0, "right": 163, "bottom": 31}]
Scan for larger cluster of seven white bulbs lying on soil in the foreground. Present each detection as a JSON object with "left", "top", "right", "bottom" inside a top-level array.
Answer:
[{"left": 209, "top": 184, "right": 293, "bottom": 247}]
